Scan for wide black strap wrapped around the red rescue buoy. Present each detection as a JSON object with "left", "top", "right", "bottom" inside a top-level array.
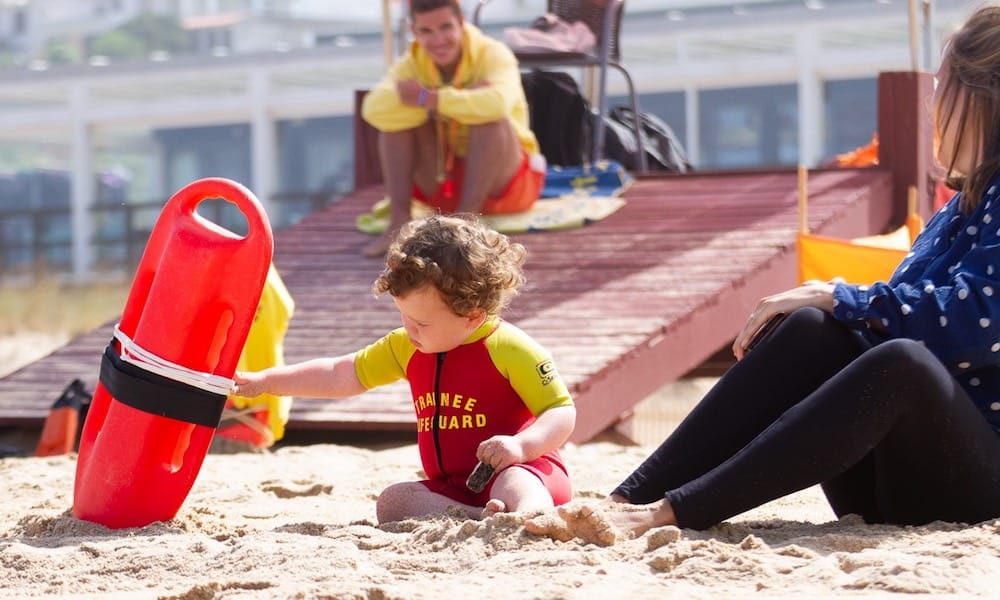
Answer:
[{"left": 101, "top": 343, "right": 226, "bottom": 428}]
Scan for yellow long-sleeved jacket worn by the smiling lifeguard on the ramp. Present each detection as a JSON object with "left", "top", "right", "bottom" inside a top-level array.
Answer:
[{"left": 361, "top": 23, "right": 539, "bottom": 156}]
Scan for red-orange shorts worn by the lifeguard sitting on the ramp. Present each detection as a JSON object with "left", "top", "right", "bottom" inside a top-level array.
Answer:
[{"left": 413, "top": 151, "right": 545, "bottom": 215}]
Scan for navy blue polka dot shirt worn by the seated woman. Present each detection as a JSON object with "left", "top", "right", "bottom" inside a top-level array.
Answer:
[{"left": 833, "top": 175, "right": 1000, "bottom": 433}]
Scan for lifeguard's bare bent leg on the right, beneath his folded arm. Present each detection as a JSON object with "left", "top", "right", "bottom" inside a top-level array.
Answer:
[{"left": 458, "top": 119, "right": 524, "bottom": 214}]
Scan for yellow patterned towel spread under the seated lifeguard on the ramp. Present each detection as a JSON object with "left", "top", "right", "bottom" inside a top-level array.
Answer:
[{"left": 355, "top": 195, "right": 625, "bottom": 234}]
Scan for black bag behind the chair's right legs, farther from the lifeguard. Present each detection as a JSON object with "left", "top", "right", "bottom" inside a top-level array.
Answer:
[{"left": 604, "top": 106, "right": 691, "bottom": 173}]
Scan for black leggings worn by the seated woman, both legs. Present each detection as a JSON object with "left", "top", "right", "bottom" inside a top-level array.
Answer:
[{"left": 615, "top": 308, "right": 1000, "bottom": 529}]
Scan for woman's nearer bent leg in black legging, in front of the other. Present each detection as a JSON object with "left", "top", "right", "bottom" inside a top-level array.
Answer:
[{"left": 666, "top": 340, "right": 1000, "bottom": 529}]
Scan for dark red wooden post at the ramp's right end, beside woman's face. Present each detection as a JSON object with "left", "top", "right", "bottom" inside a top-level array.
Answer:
[{"left": 871, "top": 71, "right": 934, "bottom": 225}]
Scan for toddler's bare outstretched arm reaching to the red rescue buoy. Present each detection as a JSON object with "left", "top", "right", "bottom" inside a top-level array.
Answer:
[{"left": 233, "top": 353, "right": 366, "bottom": 398}]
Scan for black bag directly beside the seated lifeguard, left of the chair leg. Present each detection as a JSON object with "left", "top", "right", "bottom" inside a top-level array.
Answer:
[{"left": 521, "top": 70, "right": 593, "bottom": 167}]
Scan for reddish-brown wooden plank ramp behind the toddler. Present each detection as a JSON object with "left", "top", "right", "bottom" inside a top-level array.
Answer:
[{"left": 0, "top": 169, "right": 893, "bottom": 441}]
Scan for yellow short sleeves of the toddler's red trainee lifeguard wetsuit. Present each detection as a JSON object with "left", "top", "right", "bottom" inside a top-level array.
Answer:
[{"left": 354, "top": 317, "right": 573, "bottom": 416}]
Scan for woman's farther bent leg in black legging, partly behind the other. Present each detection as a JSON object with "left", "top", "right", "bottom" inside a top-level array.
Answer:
[{"left": 613, "top": 308, "right": 868, "bottom": 504}]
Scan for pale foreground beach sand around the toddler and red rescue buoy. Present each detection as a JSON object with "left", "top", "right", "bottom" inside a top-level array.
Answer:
[{"left": 0, "top": 442, "right": 1000, "bottom": 600}]
